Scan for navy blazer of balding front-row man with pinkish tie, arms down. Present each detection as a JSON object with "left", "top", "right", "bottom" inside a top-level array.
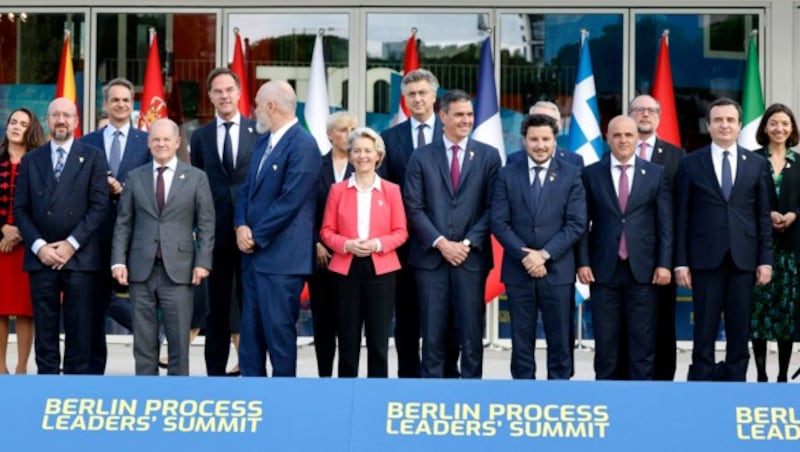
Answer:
[{"left": 578, "top": 157, "right": 673, "bottom": 284}]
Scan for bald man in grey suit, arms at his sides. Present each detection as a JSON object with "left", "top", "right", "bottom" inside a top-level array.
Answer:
[{"left": 111, "top": 118, "right": 214, "bottom": 375}]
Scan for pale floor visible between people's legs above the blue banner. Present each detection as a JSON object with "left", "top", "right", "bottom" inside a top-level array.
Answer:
[{"left": 0, "top": 335, "right": 800, "bottom": 382}]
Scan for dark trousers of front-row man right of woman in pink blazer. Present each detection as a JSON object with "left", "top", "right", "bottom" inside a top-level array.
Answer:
[{"left": 415, "top": 264, "right": 487, "bottom": 378}]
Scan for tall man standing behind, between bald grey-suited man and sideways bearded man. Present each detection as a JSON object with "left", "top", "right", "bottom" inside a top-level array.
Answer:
[{"left": 191, "top": 67, "right": 258, "bottom": 376}]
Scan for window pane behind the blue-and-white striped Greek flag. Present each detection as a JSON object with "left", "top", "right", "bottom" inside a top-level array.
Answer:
[{"left": 500, "top": 14, "right": 623, "bottom": 157}]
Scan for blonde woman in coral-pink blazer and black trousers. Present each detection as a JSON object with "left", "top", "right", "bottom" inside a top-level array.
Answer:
[{"left": 320, "top": 128, "right": 408, "bottom": 378}]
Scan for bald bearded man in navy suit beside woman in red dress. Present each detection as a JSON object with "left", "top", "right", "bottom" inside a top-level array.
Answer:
[{"left": 14, "top": 97, "right": 108, "bottom": 374}]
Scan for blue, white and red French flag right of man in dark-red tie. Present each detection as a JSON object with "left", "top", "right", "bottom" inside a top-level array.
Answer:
[{"left": 472, "top": 37, "right": 506, "bottom": 303}]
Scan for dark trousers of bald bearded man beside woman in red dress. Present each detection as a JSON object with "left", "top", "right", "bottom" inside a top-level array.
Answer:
[{"left": 29, "top": 270, "right": 97, "bottom": 374}]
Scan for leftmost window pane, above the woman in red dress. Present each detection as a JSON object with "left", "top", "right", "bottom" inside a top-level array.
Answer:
[{"left": 0, "top": 13, "right": 86, "bottom": 134}]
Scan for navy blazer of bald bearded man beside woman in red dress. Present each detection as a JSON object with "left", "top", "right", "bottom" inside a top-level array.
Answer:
[{"left": 14, "top": 141, "right": 108, "bottom": 270}]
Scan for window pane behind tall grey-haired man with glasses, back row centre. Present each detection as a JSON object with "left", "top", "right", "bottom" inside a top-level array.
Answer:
[{"left": 365, "top": 13, "right": 488, "bottom": 131}]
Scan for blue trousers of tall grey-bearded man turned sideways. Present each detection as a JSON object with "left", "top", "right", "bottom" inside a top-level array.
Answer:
[{"left": 239, "top": 269, "right": 306, "bottom": 377}]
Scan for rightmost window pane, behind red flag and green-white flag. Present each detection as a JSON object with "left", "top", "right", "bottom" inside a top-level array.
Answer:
[{"left": 635, "top": 14, "right": 758, "bottom": 150}]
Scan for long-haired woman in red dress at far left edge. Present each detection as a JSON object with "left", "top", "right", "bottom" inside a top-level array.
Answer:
[{"left": 0, "top": 108, "right": 46, "bottom": 374}]
